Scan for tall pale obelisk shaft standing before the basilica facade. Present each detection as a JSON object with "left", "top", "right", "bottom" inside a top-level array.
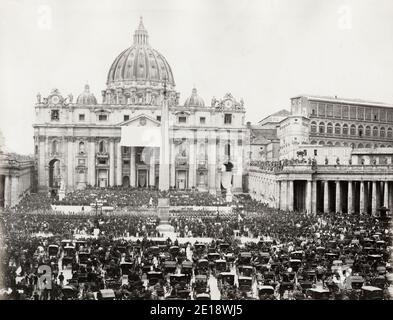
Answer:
[{"left": 158, "top": 81, "right": 169, "bottom": 191}]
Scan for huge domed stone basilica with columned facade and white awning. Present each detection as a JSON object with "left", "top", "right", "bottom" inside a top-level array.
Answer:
[{"left": 33, "top": 20, "right": 249, "bottom": 193}]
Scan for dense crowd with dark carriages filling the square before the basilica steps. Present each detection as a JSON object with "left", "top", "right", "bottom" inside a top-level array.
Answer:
[{"left": 0, "top": 189, "right": 392, "bottom": 300}]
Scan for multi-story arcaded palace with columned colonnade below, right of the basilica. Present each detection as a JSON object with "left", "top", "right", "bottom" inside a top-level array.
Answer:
[{"left": 248, "top": 96, "right": 393, "bottom": 214}]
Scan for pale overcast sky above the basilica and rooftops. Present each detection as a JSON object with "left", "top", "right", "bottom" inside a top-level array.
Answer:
[{"left": 0, "top": 0, "right": 393, "bottom": 153}]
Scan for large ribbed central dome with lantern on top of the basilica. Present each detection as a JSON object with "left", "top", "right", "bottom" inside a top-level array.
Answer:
[{"left": 107, "top": 18, "right": 175, "bottom": 89}]
